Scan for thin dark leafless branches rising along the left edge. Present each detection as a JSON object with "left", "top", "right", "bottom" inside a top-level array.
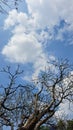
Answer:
[{"left": 0, "top": 66, "right": 23, "bottom": 130}]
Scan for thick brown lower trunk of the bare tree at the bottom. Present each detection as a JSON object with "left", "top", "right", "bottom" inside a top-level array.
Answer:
[{"left": 18, "top": 108, "right": 54, "bottom": 130}]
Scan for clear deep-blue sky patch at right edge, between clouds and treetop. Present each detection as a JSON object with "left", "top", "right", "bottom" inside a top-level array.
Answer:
[{"left": 46, "top": 40, "right": 73, "bottom": 63}]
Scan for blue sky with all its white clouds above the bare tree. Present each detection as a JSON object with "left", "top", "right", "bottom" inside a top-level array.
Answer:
[{"left": 0, "top": 0, "right": 73, "bottom": 123}]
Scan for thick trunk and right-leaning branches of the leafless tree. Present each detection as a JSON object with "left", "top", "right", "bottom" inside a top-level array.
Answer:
[{"left": 18, "top": 60, "right": 73, "bottom": 130}]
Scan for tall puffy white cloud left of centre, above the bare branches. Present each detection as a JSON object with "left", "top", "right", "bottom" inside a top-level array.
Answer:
[{"left": 2, "top": 10, "right": 47, "bottom": 78}]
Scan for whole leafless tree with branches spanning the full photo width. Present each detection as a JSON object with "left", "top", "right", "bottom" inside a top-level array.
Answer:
[{"left": 0, "top": 60, "right": 73, "bottom": 130}]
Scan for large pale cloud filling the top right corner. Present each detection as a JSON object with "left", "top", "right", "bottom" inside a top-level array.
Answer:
[{"left": 26, "top": 0, "right": 73, "bottom": 27}]
